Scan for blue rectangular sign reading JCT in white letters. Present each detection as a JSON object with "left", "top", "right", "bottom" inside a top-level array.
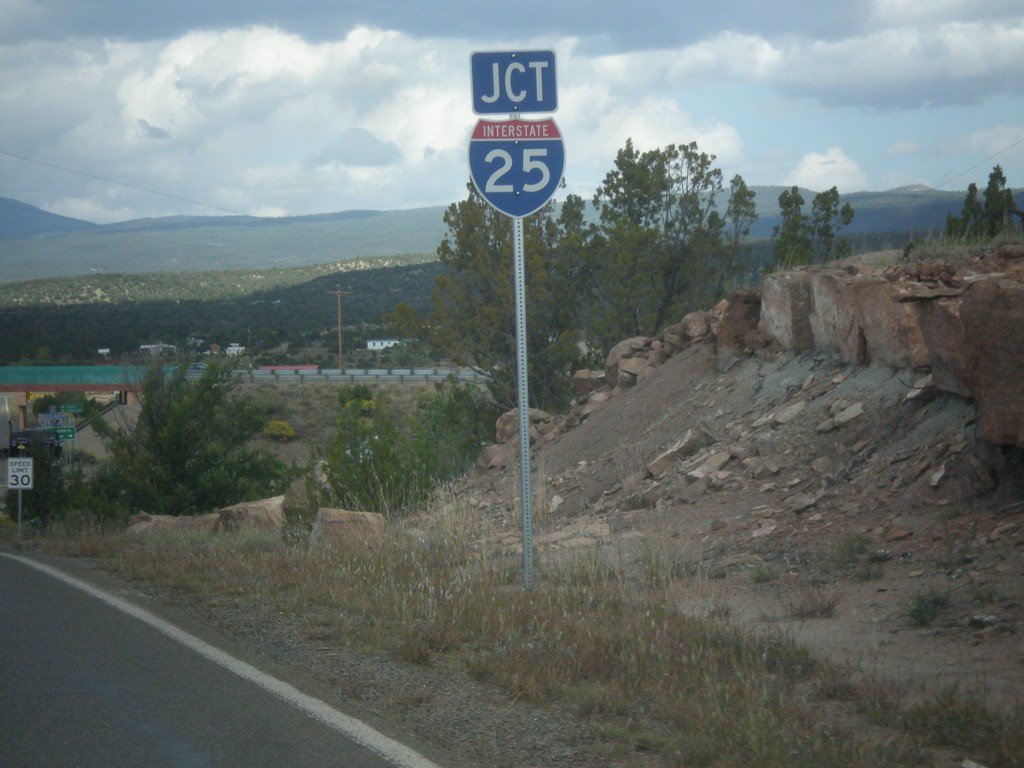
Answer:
[{"left": 470, "top": 50, "right": 558, "bottom": 115}]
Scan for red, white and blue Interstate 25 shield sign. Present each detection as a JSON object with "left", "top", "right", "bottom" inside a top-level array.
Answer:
[{"left": 469, "top": 120, "right": 565, "bottom": 216}]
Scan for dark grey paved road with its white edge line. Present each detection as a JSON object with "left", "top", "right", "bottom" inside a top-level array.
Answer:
[{"left": 0, "top": 552, "right": 448, "bottom": 768}]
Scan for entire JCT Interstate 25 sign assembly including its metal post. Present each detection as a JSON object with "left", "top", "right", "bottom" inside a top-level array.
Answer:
[{"left": 469, "top": 51, "right": 565, "bottom": 592}]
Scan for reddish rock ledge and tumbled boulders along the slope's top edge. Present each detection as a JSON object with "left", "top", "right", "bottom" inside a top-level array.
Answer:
[{"left": 477, "top": 246, "right": 1024, "bottom": 475}]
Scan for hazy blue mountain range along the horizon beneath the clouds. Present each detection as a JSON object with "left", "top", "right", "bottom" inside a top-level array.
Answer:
[{"left": 0, "top": 185, "right": 1024, "bottom": 282}]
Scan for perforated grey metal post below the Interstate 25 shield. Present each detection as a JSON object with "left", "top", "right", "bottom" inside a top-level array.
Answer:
[{"left": 512, "top": 216, "right": 534, "bottom": 592}]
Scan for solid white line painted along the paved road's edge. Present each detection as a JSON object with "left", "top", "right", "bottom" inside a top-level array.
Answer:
[{"left": 0, "top": 552, "right": 440, "bottom": 768}]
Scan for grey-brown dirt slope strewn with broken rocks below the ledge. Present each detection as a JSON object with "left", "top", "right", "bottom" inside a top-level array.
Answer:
[{"left": 470, "top": 329, "right": 1024, "bottom": 702}]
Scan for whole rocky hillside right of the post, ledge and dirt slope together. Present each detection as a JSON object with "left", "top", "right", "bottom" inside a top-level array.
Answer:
[{"left": 467, "top": 247, "right": 1024, "bottom": 701}]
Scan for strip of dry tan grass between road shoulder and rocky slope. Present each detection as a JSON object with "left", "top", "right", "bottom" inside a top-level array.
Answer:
[{"left": 39, "top": 495, "right": 1024, "bottom": 768}]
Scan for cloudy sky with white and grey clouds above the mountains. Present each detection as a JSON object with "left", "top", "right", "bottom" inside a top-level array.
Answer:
[{"left": 0, "top": 0, "right": 1024, "bottom": 222}]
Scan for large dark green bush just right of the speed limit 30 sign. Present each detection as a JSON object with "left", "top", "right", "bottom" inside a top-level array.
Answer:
[{"left": 96, "top": 364, "right": 288, "bottom": 515}]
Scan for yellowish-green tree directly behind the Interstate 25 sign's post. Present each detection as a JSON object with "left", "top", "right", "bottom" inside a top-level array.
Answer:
[{"left": 428, "top": 184, "right": 588, "bottom": 408}]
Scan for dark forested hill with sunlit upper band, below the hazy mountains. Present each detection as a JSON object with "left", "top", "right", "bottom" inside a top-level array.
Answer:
[{"left": 0, "top": 260, "right": 441, "bottom": 365}]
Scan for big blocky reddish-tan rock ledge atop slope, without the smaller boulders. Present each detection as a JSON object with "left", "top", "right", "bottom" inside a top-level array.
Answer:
[{"left": 760, "top": 250, "right": 1024, "bottom": 446}]
